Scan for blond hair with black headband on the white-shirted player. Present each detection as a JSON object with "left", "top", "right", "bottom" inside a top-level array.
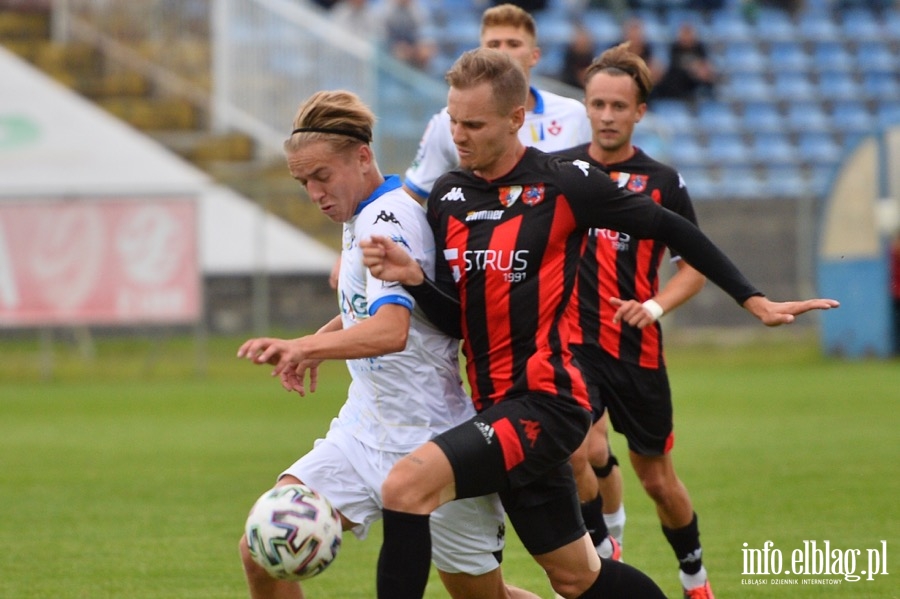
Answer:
[{"left": 284, "top": 90, "right": 375, "bottom": 152}]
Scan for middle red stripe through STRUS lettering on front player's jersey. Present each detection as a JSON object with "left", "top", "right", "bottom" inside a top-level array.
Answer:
[{"left": 484, "top": 216, "right": 522, "bottom": 397}]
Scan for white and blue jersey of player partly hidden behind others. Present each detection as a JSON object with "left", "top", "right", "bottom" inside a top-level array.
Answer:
[{"left": 405, "top": 87, "right": 591, "bottom": 198}]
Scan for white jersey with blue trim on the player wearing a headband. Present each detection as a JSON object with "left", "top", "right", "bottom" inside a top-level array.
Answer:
[{"left": 332, "top": 176, "right": 475, "bottom": 452}]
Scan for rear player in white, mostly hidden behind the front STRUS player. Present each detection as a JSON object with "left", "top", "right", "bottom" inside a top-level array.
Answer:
[{"left": 403, "top": 4, "right": 591, "bottom": 202}]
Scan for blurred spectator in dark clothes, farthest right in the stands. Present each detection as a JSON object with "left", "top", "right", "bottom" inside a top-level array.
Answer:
[{"left": 653, "top": 23, "right": 716, "bottom": 101}]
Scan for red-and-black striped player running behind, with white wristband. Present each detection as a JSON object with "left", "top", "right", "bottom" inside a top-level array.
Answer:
[{"left": 560, "top": 43, "right": 713, "bottom": 599}]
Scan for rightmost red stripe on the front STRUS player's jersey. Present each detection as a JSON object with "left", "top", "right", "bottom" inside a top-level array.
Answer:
[{"left": 526, "top": 197, "right": 590, "bottom": 410}]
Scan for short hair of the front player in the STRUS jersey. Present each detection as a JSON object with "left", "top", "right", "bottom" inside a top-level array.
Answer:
[{"left": 445, "top": 48, "right": 528, "bottom": 115}]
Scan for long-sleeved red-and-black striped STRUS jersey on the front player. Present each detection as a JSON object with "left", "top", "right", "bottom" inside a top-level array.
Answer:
[{"left": 413, "top": 148, "right": 758, "bottom": 410}]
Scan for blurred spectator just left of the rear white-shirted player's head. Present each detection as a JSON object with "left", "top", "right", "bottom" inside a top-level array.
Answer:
[{"left": 380, "top": 0, "right": 437, "bottom": 69}]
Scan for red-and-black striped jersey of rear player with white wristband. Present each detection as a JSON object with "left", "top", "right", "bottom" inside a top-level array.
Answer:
[{"left": 560, "top": 144, "right": 697, "bottom": 369}]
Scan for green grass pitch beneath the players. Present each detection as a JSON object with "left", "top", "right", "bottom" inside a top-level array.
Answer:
[{"left": 0, "top": 333, "right": 900, "bottom": 599}]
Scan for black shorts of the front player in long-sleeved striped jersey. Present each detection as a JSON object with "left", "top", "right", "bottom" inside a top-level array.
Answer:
[{"left": 434, "top": 393, "right": 591, "bottom": 555}]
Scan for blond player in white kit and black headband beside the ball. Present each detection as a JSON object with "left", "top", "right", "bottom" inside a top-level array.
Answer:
[{"left": 238, "top": 91, "right": 536, "bottom": 599}]
